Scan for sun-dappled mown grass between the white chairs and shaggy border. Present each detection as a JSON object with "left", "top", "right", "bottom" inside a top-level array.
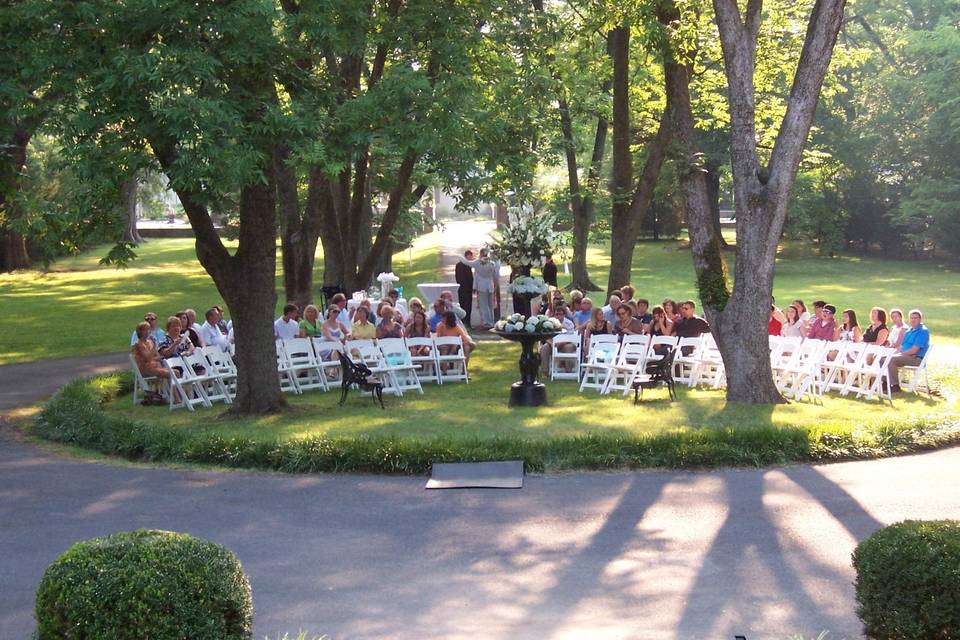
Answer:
[{"left": 108, "top": 342, "right": 955, "bottom": 440}]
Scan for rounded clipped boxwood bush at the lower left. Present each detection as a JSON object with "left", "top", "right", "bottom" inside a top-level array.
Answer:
[{"left": 36, "top": 529, "right": 253, "bottom": 640}]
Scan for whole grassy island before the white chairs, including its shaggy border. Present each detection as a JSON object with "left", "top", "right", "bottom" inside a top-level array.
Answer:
[{"left": 34, "top": 341, "right": 960, "bottom": 473}]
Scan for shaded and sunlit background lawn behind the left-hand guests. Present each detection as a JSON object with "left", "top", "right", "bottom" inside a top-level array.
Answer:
[{"left": 0, "top": 233, "right": 440, "bottom": 365}]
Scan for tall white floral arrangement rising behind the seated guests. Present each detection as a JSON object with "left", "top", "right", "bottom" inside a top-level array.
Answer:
[{"left": 490, "top": 205, "right": 560, "bottom": 268}]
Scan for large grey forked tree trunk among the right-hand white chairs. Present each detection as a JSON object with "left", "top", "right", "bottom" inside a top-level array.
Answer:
[{"left": 658, "top": 0, "right": 844, "bottom": 404}]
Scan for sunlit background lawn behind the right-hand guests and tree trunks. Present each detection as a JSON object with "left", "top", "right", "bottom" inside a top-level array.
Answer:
[{"left": 559, "top": 242, "right": 960, "bottom": 344}]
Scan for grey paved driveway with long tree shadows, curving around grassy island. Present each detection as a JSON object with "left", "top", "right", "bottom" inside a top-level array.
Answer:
[{"left": 0, "top": 356, "right": 960, "bottom": 640}]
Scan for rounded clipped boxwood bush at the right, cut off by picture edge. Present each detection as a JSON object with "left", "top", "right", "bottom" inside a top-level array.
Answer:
[{"left": 853, "top": 520, "right": 960, "bottom": 640}]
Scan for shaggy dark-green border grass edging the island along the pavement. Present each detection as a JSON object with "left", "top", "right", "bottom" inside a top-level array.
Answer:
[{"left": 35, "top": 374, "right": 960, "bottom": 474}]
